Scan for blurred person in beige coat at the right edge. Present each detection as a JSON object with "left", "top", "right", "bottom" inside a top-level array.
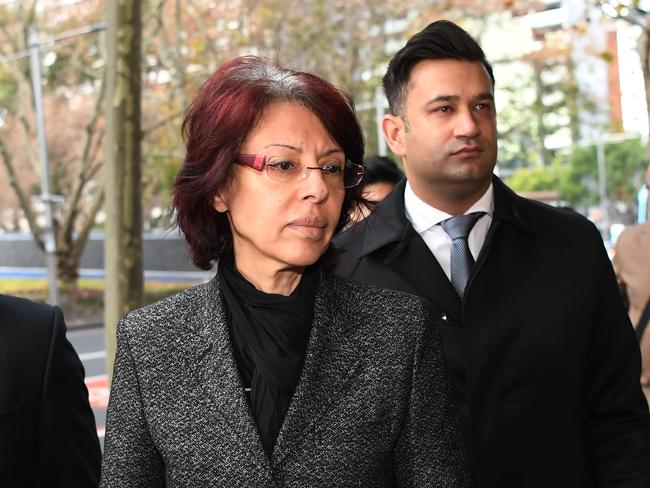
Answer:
[{"left": 614, "top": 163, "right": 650, "bottom": 402}]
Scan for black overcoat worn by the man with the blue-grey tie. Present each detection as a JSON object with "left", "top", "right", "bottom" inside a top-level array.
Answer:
[{"left": 336, "top": 177, "right": 650, "bottom": 488}]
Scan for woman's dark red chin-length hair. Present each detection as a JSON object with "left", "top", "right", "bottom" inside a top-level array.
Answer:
[{"left": 172, "top": 56, "right": 363, "bottom": 269}]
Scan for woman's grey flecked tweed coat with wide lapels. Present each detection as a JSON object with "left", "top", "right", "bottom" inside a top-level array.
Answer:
[{"left": 101, "top": 272, "right": 469, "bottom": 488}]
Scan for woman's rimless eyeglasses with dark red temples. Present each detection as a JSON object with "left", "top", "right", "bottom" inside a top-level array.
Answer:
[{"left": 236, "top": 154, "right": 364, "bottom": 188}]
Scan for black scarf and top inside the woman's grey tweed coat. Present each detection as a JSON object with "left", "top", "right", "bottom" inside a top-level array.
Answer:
[{"left": 218, "top": 255, "right": 320, "bottom": 457}]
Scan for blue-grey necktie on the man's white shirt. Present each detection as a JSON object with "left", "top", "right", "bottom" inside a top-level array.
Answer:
[{"left": 441, "top": 212, "right": 485, "bottom": 299}]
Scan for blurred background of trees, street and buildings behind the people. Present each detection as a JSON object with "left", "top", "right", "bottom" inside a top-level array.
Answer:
[{"left": 0, "top": 0, "right": 650, "bottom": 446}]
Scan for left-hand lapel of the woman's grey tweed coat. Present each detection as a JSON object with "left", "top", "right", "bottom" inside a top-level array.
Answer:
[{"left": 184, "top": 277, "right": 271, "bottom": 477}]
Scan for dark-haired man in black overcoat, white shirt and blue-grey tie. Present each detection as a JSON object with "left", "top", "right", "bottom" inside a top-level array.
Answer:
[{"left": 337, "top": 21, "right": 650, "bottom": 488}]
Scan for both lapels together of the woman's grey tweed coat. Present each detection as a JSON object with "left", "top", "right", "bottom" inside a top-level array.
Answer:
[{"left": 184, "top": 272, "right": 363, "bottom": 479}]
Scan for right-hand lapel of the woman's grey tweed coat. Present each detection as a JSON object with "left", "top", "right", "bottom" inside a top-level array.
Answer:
[{"left": 271, "top": 272, "right": 363, "bottom": 466}]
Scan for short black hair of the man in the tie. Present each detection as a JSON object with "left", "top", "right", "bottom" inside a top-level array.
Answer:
[{"left": 383, "top": 20, "right": 494, "bottom": 115}]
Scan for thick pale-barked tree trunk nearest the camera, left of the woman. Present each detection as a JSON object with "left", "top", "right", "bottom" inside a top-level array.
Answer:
[{"left": 104, "top": 0, "right": 143, "bottom": 378}]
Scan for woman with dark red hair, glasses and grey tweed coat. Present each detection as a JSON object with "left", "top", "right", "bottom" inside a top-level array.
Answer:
[{"left": 102, "top": 57, "right": 469, "bottom": 488}]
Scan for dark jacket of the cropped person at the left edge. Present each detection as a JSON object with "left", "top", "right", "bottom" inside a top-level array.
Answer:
[{"left": 0, "top": 295, "right": 101, "bottom": 488}]
